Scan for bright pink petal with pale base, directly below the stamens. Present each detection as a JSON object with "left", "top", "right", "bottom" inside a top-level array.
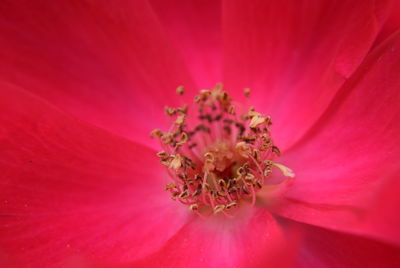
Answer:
[{"left": 131, "top": 208, "right": 295, "bottom": 268}]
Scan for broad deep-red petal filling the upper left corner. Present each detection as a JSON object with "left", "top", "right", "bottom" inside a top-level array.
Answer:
[{"left": 0, "top": 0, "right": 197, "bottom": 147}]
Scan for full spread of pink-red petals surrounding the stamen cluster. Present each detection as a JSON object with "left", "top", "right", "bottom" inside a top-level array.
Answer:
[{"left": 0, "top": 0, "right": 400, "bottom": 267}]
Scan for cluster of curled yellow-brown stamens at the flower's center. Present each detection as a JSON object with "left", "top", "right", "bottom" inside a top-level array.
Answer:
[{"left": 151, "top": 84, "right": 294, "bottom": 217}]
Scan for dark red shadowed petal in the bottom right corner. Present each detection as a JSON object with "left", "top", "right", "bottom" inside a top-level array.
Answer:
[{"left": 290, "top": 221, "right": 400, "bottom": 268}]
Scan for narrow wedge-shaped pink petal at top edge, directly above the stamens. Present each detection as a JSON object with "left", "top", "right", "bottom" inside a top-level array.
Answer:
[{"left": 150, "top": 0, "right": 222, "bottom": 88}]
